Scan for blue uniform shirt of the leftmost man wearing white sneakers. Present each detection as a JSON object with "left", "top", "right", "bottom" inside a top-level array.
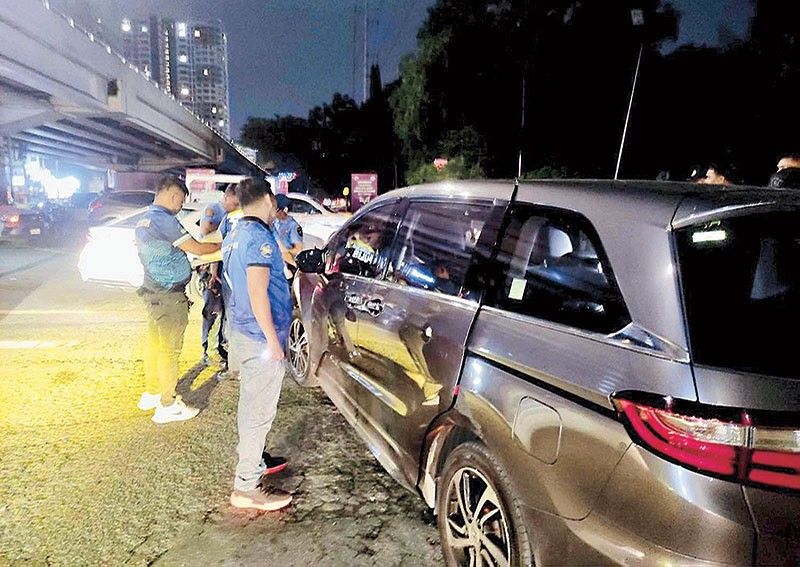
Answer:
[{"left": 136, "top": 205, "right": 192, "bottom": 292}]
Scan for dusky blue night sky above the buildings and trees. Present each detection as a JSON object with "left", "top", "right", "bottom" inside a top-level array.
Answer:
[{"left": 51, "top": 0, "right": 752, "bottom": 137}]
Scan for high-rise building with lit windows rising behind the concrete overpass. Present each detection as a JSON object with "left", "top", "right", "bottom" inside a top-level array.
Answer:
[{"left": 120, "top": 16, "right": 230, "bottom": 137}]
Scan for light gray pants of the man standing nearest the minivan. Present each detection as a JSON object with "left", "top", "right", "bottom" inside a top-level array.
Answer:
[{"left": 228, "top": 329, "right": 286, "bottom": 490}]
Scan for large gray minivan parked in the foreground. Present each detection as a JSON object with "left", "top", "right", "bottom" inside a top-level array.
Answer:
[{"left": 288, "top": 181, "right": 800, "bottom": 566}]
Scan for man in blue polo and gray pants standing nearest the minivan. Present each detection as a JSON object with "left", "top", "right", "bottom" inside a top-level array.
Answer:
[{"left": 222, "top": 179, "right": 292, "bottom": 510}]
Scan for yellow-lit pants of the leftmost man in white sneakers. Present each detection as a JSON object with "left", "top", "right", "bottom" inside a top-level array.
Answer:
[{"left": 141, "top": 291, "right": 189, "bottom": 406}]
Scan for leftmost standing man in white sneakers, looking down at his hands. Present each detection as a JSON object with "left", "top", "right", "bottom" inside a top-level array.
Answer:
[{"left": 136, "top": 176, "right": 220, "bottom": 423}]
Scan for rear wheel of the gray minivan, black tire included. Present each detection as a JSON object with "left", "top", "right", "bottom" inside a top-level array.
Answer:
[{"left": 436, "top": 442, "right": 533, "bottom": 567}]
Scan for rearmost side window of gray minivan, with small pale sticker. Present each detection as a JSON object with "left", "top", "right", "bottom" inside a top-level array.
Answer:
[{"left": 489, "top": 205, "right": 630, "bottom": 334}]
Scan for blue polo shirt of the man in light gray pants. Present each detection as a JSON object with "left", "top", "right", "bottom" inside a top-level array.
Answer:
[{"left": 222, "top": 217, "right": 292, "bottom": 348}]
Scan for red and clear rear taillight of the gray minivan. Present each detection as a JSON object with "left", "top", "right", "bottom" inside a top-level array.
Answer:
[{"left": 611, "top": 392, "right": 800, "bottom": 490}]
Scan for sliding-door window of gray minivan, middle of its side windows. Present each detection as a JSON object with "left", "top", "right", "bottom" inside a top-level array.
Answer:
[{"left": 386, "top": 201, "right": 491, "bottom": 297}]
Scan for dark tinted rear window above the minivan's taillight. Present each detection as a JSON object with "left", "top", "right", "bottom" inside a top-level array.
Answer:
[{"left": 676, "top": 211, "right": 800, "bottom": 378}]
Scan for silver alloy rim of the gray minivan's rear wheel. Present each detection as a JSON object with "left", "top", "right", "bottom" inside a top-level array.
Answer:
[{"left": 442, "top": 467, "right": 512, "bottom": 567}]
